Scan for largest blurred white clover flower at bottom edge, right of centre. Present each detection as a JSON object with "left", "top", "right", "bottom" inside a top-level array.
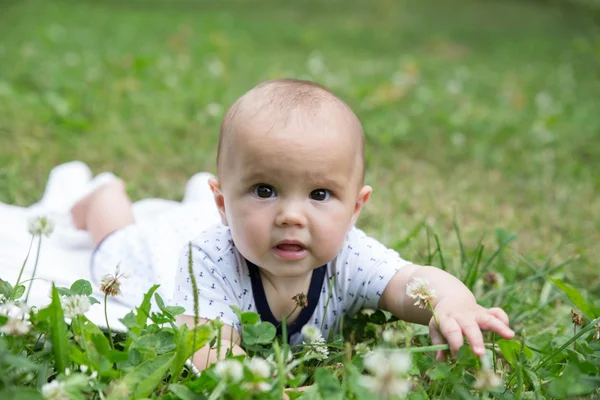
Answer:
[{"left": 360, "top": 349, "right": 411, "bottom": 399}]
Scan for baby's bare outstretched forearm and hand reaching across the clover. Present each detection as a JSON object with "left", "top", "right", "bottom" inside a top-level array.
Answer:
[{"left": 379, "top": 264, "right": 514, "bottom": 359}]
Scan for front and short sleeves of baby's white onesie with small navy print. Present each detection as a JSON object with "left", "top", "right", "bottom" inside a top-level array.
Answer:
[{"left": 174, "top": 225, "right": 408, "bottom": 344}]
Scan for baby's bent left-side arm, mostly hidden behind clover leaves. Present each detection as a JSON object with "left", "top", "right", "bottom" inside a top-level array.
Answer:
[{"left": 177, "top": 315, "right": 246, "bottom": 371}]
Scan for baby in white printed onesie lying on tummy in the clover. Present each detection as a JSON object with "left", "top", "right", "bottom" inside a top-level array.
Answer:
[{"left": 72, "top": 79, "right": 514, "bottom": 369}]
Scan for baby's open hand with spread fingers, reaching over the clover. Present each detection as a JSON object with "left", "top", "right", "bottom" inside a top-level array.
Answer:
[{"left": 429, "top": 297, "right": 515, "bottom": 361}]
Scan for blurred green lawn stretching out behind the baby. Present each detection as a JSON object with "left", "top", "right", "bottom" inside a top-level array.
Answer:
[{"left": 0, "top": 0, "right": 600, "bottom": 291}]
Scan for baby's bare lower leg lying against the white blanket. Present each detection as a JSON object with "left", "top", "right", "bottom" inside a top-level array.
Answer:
[{"left": 71, "top": 179, "right": 134, "bottom": 246}]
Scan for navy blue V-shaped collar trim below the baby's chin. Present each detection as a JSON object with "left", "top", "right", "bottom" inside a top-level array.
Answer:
[{"left": 246, "top": 260, "right": 327, "bottom": 341}]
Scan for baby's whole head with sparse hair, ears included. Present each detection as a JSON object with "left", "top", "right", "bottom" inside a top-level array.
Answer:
[{"left": 210, "top": 79, "right": 371, "bottom": 277}]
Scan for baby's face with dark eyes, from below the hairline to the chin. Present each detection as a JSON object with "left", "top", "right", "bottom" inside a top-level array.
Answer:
[{"left": 212, "top": 108, "right": 371, "bottom": 278}]
